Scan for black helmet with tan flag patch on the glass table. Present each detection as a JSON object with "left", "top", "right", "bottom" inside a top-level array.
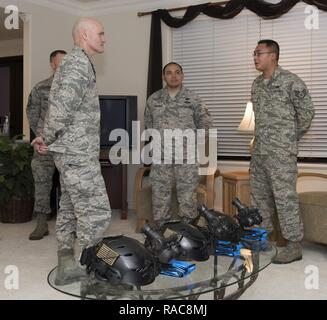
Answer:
[{"left": 81, "top": 235, "right": 160, "bottom": 286}]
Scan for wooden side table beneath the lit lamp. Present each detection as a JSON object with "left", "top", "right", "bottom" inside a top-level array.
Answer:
[{"left": 222, "top": 171, "right": 250, "bottom": 215}]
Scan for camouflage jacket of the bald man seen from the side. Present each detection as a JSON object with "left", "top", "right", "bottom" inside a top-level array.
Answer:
[{"left": 44, "top": 46, "right": 100, "bottom": 158}]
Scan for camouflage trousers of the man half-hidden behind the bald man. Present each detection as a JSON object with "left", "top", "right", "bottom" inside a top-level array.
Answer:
[{"left": 31, "top": 152, "right": 55, "bottom": 214}]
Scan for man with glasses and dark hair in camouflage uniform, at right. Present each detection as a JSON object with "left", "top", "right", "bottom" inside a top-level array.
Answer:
[{"left": 250, "top": 40, "right": 314, "bottom": 263}]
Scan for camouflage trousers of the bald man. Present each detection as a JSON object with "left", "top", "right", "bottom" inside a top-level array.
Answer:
[{"left": 53, "top": 153, "right": 111, "bottom": 250}]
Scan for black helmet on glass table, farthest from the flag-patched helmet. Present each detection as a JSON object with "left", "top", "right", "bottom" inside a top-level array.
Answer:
[{"left": 198, "top": 205, "right": 243, "bottom": 242}]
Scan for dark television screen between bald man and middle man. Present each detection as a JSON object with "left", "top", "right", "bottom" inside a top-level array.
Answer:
[{"left": 99, "top": 95, "right": 137, "bottom": 148}]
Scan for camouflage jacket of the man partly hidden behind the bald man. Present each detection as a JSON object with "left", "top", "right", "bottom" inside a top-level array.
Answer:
[{"left": 26, "top": 75, "right": 53, "bottom": 136}]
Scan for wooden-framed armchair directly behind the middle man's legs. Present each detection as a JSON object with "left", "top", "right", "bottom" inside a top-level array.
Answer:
[{"left": 134, "top": 167, "right": 220, "bottom": 232}]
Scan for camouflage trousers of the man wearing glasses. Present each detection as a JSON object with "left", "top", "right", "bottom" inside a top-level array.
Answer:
[{"left": 250, "top": 154, "right": 303, "bottom": 241}]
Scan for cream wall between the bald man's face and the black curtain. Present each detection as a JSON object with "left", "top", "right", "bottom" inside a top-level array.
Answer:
[{"left": 93, "top": 11, "right": 150, "bottom": 207}]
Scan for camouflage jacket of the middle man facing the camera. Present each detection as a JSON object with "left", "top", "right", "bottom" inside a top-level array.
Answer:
[{"left": 144, "top": 86, "right": 212, "bottom": 159}]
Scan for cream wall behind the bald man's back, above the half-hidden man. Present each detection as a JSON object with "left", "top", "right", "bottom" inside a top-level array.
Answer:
[{"left": 0, "top": 0, "right": 76, "bottom": 139}]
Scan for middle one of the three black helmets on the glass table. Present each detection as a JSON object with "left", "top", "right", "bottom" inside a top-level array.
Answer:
[{"left": 162, "top": 221, "right": 210, "bottom": 261}]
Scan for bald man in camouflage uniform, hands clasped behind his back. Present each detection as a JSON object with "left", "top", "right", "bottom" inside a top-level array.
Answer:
[{"left": 32, "top": 18, "right": 111, "bottom": 285}]
